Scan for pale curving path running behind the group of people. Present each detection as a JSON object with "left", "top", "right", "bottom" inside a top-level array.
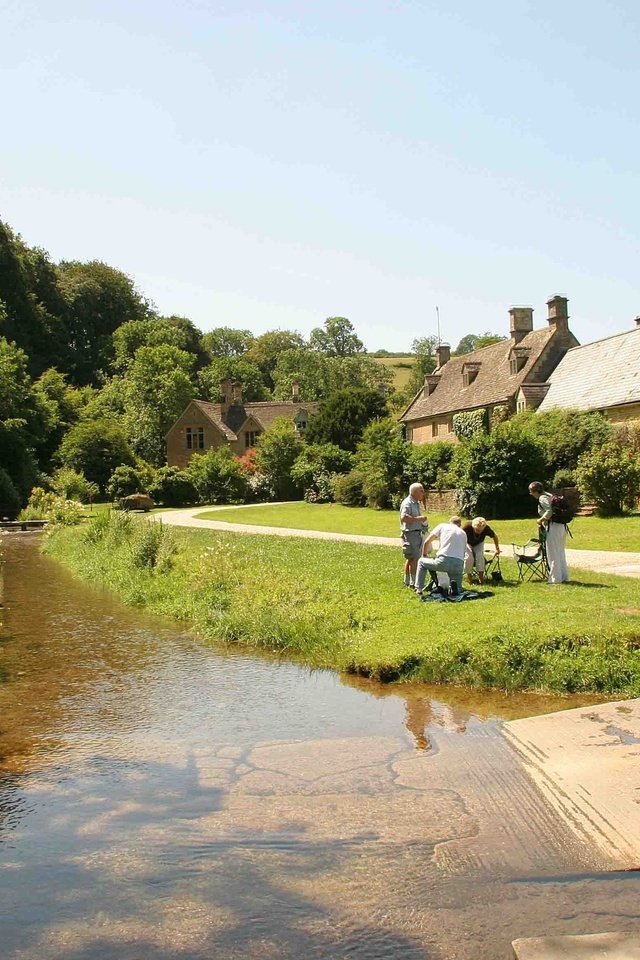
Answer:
[{"left": 154, "top": 504, "right": 640, "bottom": 578}]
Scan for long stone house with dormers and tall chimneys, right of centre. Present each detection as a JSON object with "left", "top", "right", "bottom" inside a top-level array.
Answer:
[{"left": 399, "top": 296, "right": 578, "bottom": 444}]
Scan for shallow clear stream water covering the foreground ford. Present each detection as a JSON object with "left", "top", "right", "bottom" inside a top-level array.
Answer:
[{"left": 0, "top": 534, "right": 640, "bottom": 960}]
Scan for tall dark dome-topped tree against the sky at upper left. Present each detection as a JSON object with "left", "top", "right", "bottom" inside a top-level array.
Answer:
[{"left": 58, "top": 260, "right": 149, "bottom": 384}]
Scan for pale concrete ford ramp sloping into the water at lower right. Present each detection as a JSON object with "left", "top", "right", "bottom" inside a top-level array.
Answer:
[{"left": 505, "top": 699, "right": 640, "bottom": 872}]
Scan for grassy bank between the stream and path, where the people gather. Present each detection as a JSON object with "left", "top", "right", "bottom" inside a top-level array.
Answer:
[{"left": 45, "top": 515, "right": 640, "bottom": 696}]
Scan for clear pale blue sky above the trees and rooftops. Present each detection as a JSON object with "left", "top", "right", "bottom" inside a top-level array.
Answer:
[{"left": 0, "top": 0, "right": 640, "bottom": 351}]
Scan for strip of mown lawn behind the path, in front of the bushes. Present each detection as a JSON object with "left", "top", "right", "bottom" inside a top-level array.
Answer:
[{"left": 198, "top": 502, "right": 640, "bottom": 551}]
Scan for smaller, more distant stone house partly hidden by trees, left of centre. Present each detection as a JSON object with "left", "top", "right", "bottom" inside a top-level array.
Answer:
[{"left": 165, "top": 380, "right": 318, "bottom": 467}]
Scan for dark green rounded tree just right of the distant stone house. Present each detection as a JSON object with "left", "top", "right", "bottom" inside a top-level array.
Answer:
[{"left": 306, "top": 387, "right": 387, "bottom": 452}]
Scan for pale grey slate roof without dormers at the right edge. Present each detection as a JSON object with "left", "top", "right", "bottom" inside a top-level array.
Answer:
[{"left": 538, "top": 328, "right": 640, "bottom": 410}]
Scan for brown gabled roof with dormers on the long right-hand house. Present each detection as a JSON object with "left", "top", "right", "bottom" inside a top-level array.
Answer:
[{"left": 400, "top": 326, "right": 555, "bottom": 421}]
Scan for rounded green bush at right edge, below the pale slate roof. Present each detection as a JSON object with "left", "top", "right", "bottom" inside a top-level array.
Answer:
[{"left": 576, "top": 435, "right": 640, "bottom": 517}]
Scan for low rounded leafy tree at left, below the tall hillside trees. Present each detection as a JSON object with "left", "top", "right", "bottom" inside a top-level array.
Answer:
[{"left": 57, "top": 420, "right": 135, "bottom": 493}]
